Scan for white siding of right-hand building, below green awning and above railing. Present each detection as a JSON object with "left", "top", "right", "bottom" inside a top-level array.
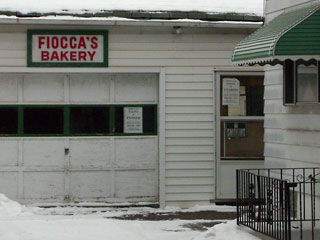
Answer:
[{"left": 264, "top": 65, "right": 320, "bottom": 168}]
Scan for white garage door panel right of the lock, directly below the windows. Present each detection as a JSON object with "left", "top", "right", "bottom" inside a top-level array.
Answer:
[{"left": 70, "top": 139, "right": 111, "bottom": 168}]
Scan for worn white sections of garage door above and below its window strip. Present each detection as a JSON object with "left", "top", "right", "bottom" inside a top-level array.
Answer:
[{"left": 0, "top": 73, "right": 159, "bottom": 203}]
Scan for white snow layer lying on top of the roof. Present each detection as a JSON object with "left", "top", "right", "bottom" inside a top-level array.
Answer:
[{"left": 0, "top": 0, "right": 263, "bottom": 16}]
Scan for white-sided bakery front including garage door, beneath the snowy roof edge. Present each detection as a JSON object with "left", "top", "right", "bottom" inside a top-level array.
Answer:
[{"left": 0, "top": 13, "right": 262, "bottom": 207}]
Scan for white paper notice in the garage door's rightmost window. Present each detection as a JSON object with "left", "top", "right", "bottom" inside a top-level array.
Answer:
[{"left": 123, "top": 107, "right": 143, "bottom": 133}]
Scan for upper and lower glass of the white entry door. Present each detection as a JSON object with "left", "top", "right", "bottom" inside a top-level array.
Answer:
[{"left": 220, "top": 76, "right": 264, "bottom": 160}]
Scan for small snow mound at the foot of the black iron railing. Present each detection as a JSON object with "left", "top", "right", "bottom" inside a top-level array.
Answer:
[{"left": 193, "top": 220, "right": 259, "bottom": 240}]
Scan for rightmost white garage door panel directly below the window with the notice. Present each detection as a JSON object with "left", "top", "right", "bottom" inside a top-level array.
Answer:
[{"left": 115, "top": 137, "right": 158, "bottom": 168}]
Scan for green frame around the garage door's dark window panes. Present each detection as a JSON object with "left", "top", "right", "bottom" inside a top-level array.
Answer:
[{"left": 0, "top": 104, "right": 158, "bottom": 137}]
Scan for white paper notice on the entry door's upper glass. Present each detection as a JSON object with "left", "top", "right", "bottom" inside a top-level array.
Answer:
[{"left": 222, "top": 78, "right": 240, "bottom": 105}]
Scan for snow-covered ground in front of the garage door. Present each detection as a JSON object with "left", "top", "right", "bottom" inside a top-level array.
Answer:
[{"left": 0, "top": 194, "right": 257, "bottom": 240}]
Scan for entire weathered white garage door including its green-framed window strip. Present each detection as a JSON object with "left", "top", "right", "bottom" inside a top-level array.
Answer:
[{"left": 0, "top": 74, "right": 158, "bottom": 202}]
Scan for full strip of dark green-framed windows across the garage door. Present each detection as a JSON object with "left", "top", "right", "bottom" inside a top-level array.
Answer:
[{"left": 0, "top": 105, "right": 157, "bottom": 136}]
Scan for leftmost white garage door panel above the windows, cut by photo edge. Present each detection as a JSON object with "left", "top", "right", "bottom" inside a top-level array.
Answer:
[{"left": 0, "top": 74, "right": 22, "bottom": 103}]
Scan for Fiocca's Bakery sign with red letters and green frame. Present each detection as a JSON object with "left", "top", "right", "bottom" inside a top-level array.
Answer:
[{"left": 27, "top": 30, "right": 108, "bottom": 67}]
